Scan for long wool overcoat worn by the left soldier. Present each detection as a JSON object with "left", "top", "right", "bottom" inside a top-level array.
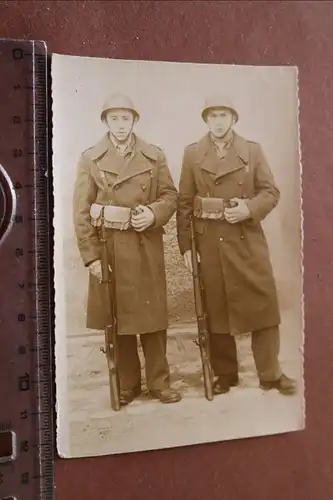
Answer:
[{"left": 74, "top": 134, "right": 177, "bottom": 335}]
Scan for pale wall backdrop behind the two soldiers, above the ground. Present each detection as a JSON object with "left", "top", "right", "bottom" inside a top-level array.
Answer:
[{"left": 52, "top": 56, "right": 302, "bottom": 336}]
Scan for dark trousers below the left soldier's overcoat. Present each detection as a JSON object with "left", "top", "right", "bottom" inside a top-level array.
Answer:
[{"left": 117, "top": 330, "right": 170, "bottom": 391}]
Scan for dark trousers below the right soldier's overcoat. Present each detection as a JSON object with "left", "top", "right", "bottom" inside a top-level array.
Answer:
[{"left": 210, "top": 326, "right": 282, "bottom": 382}]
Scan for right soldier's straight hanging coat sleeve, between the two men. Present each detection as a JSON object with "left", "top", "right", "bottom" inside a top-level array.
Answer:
[{"left": 176, "top": 148, "right": 197, "bottom": 255}]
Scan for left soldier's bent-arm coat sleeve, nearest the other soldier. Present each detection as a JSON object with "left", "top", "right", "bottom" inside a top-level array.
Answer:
[{"left": 148, "top": 148, "right": 178, "bottom": 228}]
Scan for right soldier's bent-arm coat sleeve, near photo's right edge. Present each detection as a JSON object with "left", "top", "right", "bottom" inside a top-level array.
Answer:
[{"left": 247, "top": 144, "right": 280, "bottom": 222}]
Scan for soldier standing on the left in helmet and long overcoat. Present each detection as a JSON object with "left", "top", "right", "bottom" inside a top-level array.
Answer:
[{"left": 74, "top": 93, "right": 180, "bottom": 405}]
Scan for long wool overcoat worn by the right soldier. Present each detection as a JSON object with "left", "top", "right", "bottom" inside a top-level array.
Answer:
[{"left": 177, "top": 133, "right": 280, "bottom": 334}]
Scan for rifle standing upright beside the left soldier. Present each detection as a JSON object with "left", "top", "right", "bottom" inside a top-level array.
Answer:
[{"left": 100, "top": 207, "right": 120, "bottom": 411}]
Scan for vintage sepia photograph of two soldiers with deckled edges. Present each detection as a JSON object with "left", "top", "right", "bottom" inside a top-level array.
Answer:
[{"left": 52, "top": 54, "right": 305, "bottom": 458}]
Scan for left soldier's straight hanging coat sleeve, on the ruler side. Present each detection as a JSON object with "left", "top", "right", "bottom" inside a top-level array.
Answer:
[{"left": 73, "top": 154, "right": 100, "bottom": 266}]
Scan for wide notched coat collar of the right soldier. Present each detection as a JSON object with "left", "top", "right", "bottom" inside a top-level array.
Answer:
[{"left": 197, "top": 132, "right": 249, "bottom": 178}]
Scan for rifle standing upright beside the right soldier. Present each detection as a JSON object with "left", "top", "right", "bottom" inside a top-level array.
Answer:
[{"left": 190, "top": 218, "right": 213, "bottom": 401}]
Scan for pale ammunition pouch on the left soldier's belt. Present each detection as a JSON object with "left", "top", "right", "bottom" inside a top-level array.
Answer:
[{"left": 90, "top": 203, "right": 131, "bottom": 231}]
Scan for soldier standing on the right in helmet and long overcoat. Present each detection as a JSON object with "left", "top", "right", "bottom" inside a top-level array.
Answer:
[{"left": 177, "top": 95, "right": 295, "bottom": 394}]
